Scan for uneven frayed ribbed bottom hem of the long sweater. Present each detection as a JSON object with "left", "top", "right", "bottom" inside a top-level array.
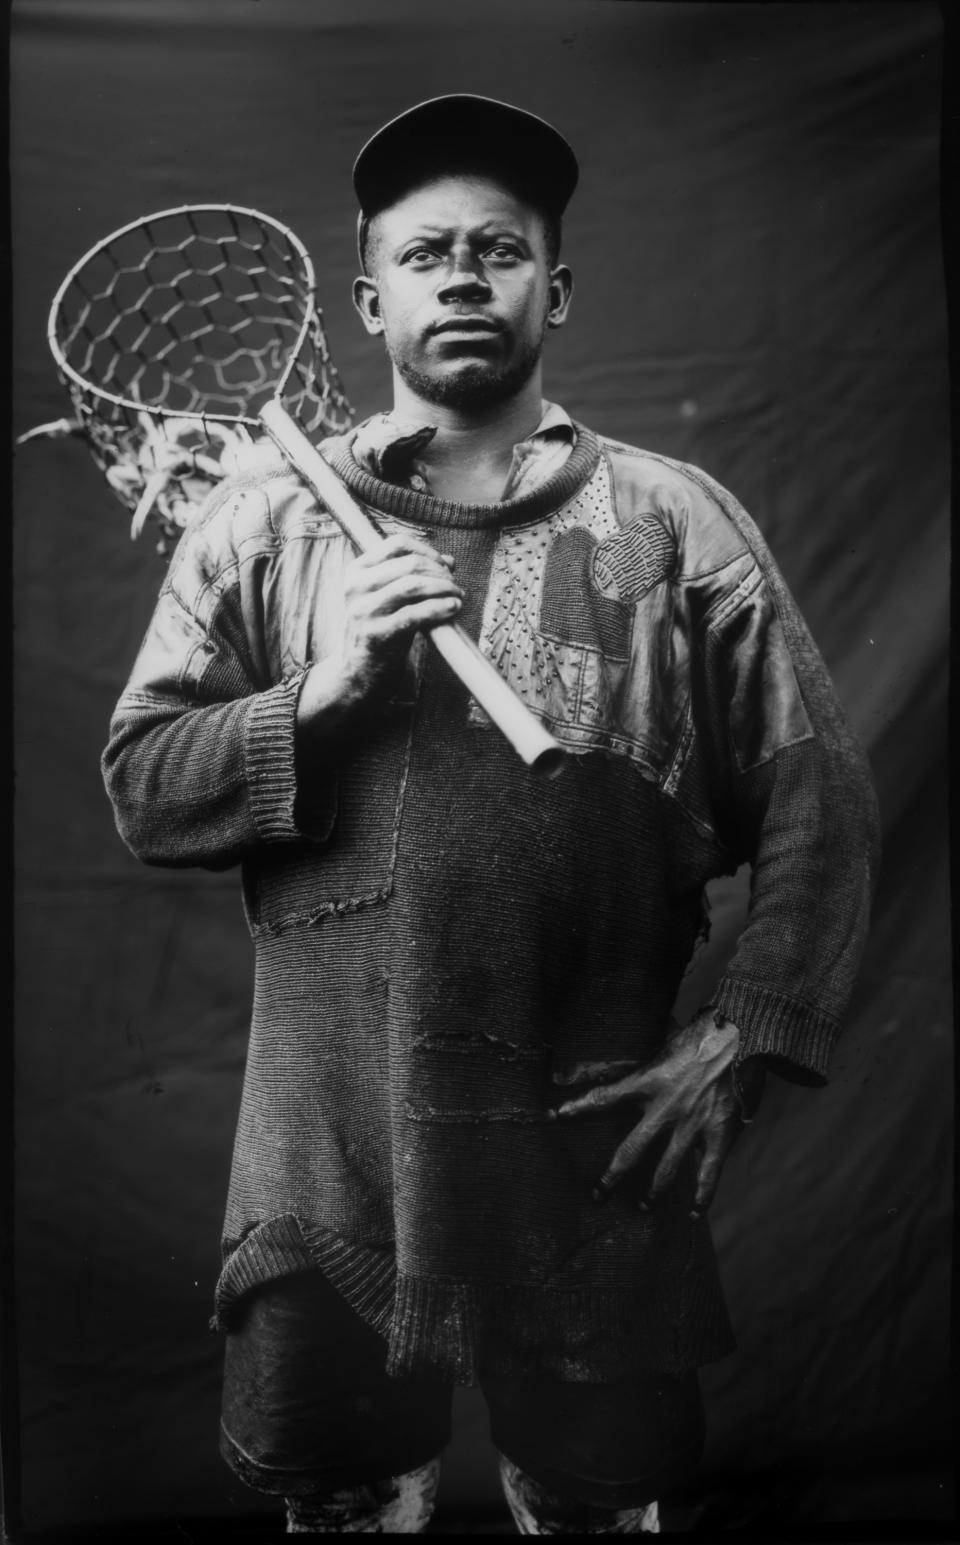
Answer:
[{"left": 210, "top": 1213, "right": 736, "bottom": 1386}]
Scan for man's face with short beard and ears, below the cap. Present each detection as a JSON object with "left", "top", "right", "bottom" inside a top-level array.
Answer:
[{"left": 354, "top": 176, "right": 569, "bottom": 408}]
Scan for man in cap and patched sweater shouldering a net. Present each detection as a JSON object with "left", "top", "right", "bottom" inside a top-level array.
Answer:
[{"left": 105, "top": 96, "right": 877, "bottom": 1534}]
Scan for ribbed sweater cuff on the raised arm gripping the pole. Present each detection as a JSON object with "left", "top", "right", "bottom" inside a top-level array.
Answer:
[{"left": 244, "top": 671, "right": 337, "bottom": 842}]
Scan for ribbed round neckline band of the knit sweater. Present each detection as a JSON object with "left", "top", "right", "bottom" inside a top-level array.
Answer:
[{"left": 322, "top": 422, "right": 600, "bottom": 530}]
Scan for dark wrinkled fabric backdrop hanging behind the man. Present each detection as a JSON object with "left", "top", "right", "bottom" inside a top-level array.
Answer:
[{"left": 8, "top": 0, "right": 951, "bottom": 1539}]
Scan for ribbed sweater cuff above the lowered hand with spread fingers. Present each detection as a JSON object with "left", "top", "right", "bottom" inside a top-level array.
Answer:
[{"left": 710, "top": 976, "right": 839, "bottom": 1085}]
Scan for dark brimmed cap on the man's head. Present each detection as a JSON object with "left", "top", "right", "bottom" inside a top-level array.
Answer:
[{"left": 352, "top": 93, "right": 580, "bottom": 218}]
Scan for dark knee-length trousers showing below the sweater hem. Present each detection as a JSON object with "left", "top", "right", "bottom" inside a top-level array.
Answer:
[{"left": 221, "top": 1272, "right": 703, "bottom": 1508}]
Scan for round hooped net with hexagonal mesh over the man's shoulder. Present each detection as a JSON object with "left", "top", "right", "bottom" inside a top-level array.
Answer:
[{"left": 49, "top": 205, "right": 352, "bottom": 550}]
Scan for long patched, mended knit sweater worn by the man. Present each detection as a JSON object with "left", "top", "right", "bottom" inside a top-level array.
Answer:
[{"left": 104, "top": 426, "right": 877, "bottom": 1383}]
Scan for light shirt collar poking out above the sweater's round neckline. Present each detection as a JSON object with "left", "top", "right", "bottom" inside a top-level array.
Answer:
[{"left": 352, "top": 402, "right": 577, "bottom": 501}]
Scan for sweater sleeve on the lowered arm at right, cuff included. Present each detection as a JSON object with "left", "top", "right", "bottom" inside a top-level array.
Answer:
[{"left": 677, "top": 468, "right": 880, "bottom": 1083}]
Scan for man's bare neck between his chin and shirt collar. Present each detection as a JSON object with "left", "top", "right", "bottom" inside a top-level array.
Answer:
[{"left": 394, "top": 371, "right": 543, "bottom": 504}]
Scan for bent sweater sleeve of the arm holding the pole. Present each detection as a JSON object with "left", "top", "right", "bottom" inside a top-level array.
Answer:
[{"left": 102, "top": 493, "right": 335, "bottom": 868}]
